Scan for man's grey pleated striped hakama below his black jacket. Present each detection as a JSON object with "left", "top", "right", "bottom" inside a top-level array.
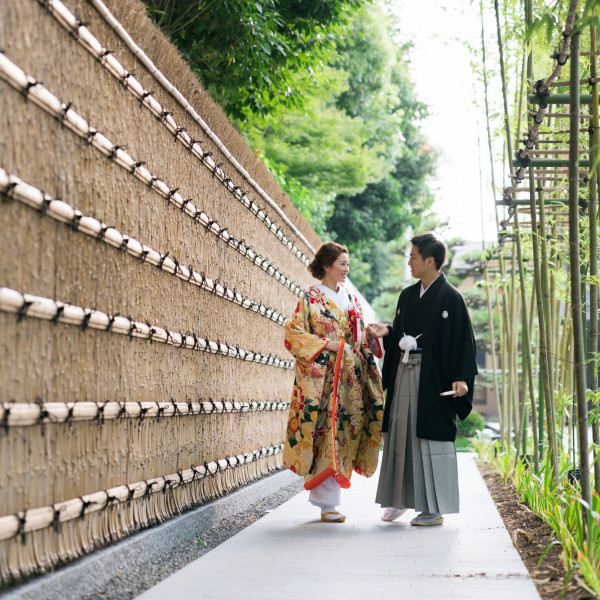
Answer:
[{"left": 376, "top": 354, "right": 458, "bottom": 514}]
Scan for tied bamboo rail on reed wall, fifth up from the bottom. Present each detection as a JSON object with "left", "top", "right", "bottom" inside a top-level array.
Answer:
[{"left": 0, "top": 53, "right": 304, "bottom": 296}]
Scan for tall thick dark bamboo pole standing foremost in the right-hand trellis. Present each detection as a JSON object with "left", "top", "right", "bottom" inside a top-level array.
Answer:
[{"left": 569, "top": 23, "right": 591, "bottom": 512}]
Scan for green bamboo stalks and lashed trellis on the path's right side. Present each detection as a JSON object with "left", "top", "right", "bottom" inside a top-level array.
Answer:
[{"left": 482, "top": 0, "right": 600, "bottom": 502}]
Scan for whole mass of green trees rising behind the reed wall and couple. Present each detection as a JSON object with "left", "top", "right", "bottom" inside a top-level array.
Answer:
[{"left": 147, "top": 0, "right": 436, "bottom": 304}]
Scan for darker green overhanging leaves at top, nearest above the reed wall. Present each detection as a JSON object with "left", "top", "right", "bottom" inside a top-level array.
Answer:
[{"left": 145, "top": 0, "right": 364, "bottom": 119}]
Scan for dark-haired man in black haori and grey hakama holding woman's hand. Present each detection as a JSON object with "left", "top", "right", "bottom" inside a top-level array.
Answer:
[{"left": 366, "top": 233, "right": 477, "bottom": 525}]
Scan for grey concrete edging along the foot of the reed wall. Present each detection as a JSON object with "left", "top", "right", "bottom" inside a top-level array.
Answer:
[{"left": 0, "top": 470, "right": 301, "bottom": 600}]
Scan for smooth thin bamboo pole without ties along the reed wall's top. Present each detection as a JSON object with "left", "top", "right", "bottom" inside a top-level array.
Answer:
[{"left": 85, "top": 0, "right": 315, "bottom": 253}]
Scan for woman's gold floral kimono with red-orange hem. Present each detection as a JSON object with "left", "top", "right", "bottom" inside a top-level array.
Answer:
[{"left": 283, "top": 287, "right": 383, "bottom": 490}]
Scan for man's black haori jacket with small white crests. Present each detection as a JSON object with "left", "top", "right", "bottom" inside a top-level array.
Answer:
[{"left": 382, "top": 274, "right": 477, "bottom": 442}]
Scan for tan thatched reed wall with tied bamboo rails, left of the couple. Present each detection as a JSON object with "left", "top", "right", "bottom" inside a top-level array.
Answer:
[{"left": 0, "top": 0, "right": 319, "bottom": 584}]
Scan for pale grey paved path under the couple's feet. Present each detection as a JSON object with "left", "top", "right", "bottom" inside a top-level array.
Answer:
[{"left": 139, "top": 453, "right": 539, "bottom": 600}]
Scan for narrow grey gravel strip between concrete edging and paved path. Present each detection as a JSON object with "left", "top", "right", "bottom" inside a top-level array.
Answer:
[{"left": 81, "top": 480, "right": 304, "bottom": 600}]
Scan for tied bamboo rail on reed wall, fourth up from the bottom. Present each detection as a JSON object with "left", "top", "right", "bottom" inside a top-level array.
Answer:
[{"left": 0, "top": 167, "right": 287, "bottom": 326}]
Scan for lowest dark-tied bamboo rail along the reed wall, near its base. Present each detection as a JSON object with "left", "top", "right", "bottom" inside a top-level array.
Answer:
[{"left": 0, "top": 444, "right": 283, "bottom": 540}]
